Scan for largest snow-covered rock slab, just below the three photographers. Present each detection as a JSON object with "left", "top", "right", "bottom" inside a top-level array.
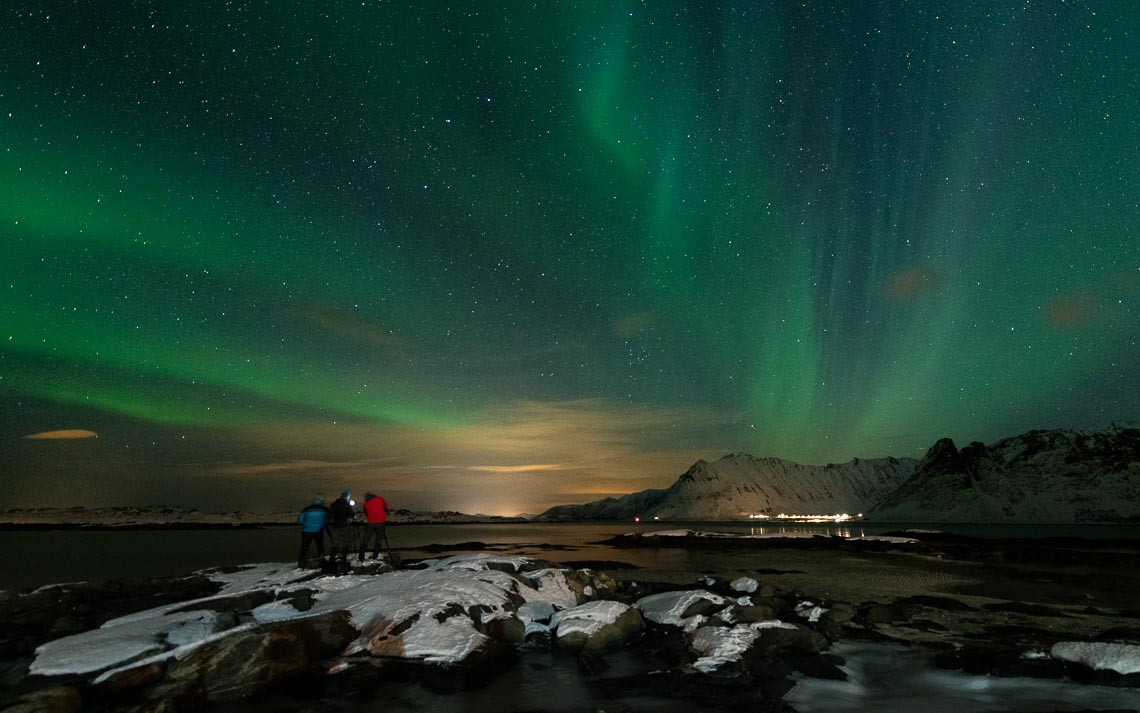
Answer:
[{"left": 30, "top": 554, "right": 592, "bottom": 676}]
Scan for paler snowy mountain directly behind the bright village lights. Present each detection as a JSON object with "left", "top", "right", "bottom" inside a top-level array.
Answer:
[{"left": 539, "top": 453, "right": 918, "bottom": 520}]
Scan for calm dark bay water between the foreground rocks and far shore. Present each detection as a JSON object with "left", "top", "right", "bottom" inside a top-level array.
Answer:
[{"left": 0, "top": 522, "right": 1140, "bottom": 591}]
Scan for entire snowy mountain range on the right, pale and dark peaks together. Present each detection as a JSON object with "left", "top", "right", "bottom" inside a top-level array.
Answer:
[{"left": 536, "top": 422, "right": 1140, "bottom": 524}]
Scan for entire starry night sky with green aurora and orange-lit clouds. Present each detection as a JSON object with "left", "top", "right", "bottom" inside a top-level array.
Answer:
[{"left": 0, "top": 0, "right": 1140, "bottom": 515}]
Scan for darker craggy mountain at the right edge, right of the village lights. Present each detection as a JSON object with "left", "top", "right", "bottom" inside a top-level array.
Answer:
[{"left": 869, "top": 424, "right": 1140, "bottom": 522}]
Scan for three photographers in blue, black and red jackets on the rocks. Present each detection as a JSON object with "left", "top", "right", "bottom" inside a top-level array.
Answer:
[{"left": 296, "top": 491, "right": 390, "bottom": 567}]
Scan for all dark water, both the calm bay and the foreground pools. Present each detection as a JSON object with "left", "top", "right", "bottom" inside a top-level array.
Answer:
[{"left": 0, "top": 522, "right": 1140, "bottom": 713}]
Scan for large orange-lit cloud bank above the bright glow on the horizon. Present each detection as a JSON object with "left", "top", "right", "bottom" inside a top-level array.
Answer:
[{"left": 215, "top": 398, "right": 725, "bottom": 513}]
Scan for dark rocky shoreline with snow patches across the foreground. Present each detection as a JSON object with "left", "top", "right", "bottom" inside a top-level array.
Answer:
[{"left": 0, "top": 533, "right": 1140, "bottom": 713}]
